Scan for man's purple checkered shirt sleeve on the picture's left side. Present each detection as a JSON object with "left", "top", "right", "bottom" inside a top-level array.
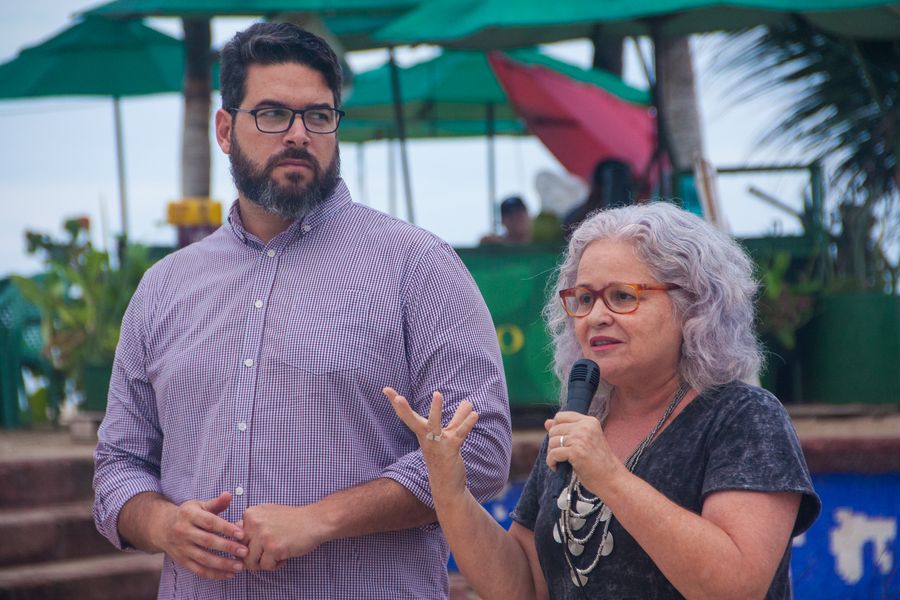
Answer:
[{"left": 94, "top": 275, "right": 163, "bottom": 549}]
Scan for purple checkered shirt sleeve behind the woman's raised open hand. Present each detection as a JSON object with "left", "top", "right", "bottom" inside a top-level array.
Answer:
[{"left": 382, "top": 244, "right": 512, "bottom": 507}]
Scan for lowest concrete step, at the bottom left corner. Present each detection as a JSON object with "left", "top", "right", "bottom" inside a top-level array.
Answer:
[{"left": 0, "top": 553, "right": 163, "bottom": 600}]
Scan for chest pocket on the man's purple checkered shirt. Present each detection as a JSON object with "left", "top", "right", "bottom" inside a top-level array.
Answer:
[{"left": 273, "top": 290, "right": 372, "bottom": 375}]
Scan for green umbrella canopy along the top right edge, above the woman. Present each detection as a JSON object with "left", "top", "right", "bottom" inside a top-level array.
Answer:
[{"left": 375, "top": 0, "right": 900, "bottom": 48}]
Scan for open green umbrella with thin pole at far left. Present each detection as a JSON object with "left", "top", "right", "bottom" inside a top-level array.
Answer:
[{"left": 0, "top": 17, "right": 214, "bottom": 235}]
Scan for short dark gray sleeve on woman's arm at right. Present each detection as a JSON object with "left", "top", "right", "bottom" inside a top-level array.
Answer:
[{"left": 703, "top": 387, "right": 821, "bottom": 535}]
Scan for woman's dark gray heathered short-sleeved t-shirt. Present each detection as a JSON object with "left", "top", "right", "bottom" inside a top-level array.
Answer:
[{"left": 511, "top": 383, "right": 821, "bottom": 600}]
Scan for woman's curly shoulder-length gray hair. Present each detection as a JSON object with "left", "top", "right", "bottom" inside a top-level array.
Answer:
[{"left": 544, "top": 202, "right": 762, "bottom": 398}]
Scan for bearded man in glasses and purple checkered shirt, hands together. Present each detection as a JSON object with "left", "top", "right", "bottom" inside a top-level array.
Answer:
[{"left": 94, "top": 23, "right": 511, "bottom": 600}]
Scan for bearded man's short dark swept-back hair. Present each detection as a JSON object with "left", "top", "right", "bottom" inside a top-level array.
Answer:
[{"left": 219, "top": 23, "right": 342, "bottom": 110}]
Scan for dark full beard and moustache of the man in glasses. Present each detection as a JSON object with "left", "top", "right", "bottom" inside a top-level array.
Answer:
[{"left": 229, "top": 134, "right": 341, "bottom": 220}]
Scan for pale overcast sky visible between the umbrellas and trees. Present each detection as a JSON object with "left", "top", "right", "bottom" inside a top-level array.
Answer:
[{"left": 0, "top": 0, "right": 816, "bottom": 277}]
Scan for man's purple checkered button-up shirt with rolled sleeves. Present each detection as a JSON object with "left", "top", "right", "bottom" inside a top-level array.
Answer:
[{"left": 94, "top": 181, "right": 511, "bottom": 600}]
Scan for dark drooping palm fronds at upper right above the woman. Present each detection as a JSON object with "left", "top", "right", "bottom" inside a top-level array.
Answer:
[{"left": 720, "top": 18, "right": 900, "bottom": 293}]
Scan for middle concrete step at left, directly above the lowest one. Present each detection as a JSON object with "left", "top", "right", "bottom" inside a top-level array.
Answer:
[{"left": 0, "top": 500, "right": 117, "bottom": 567}]
